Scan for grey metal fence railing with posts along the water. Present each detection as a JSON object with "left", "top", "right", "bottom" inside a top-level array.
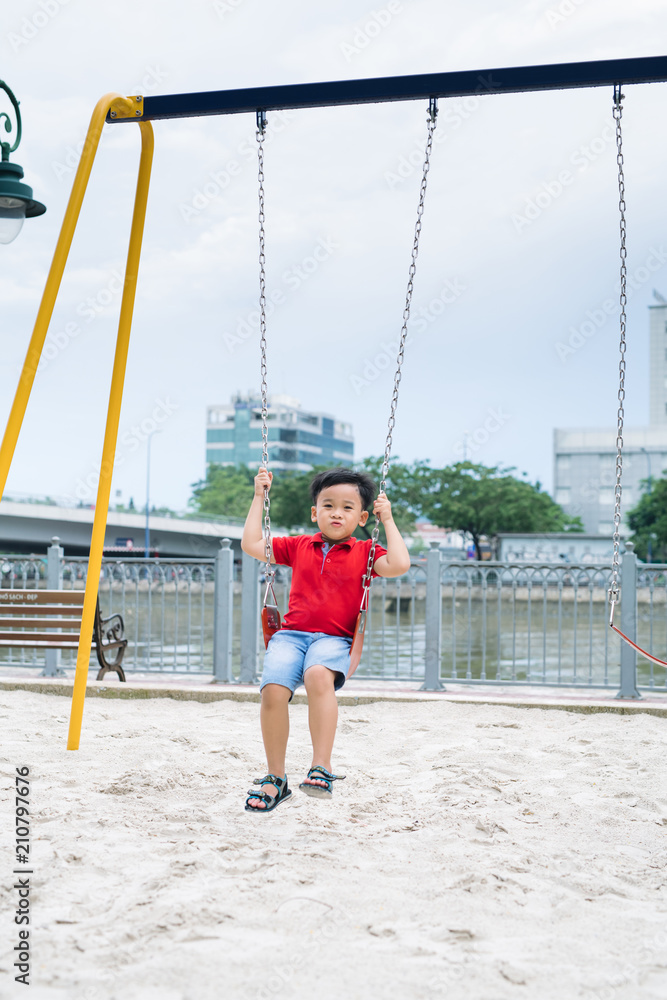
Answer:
[{"left": 0, "top": 539, "right": 667, "bottom": 697}]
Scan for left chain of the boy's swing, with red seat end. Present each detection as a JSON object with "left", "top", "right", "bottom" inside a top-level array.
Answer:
[{"left": 256, "top": 111, "right": 281, "bottom": 646}]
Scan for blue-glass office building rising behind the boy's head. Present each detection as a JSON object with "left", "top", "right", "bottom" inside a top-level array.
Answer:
[{"left": 206, "top": 393, "right": 354, "bottom": 472}]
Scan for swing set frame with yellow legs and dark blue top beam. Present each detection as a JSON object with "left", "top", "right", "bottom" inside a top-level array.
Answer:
[{"left": 0, "top": 56, "right": 667, "bottom": 750}]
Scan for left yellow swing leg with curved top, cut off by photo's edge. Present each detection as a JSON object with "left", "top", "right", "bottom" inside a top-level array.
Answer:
[{"left": 0, "top": 93, "right": 135, "bottom": 497}]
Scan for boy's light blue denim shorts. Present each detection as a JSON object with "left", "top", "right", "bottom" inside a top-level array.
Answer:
[{"left": 259, "top": 628, "right": 352, "bottom": 701}]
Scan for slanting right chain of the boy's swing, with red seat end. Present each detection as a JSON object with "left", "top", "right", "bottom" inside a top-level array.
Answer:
[{"left": 347, "top": 97, "right": 438, "bottom": 677}]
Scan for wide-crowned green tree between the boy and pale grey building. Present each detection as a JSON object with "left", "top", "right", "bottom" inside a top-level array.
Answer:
[{"left": 419, "top": 462, "right": 583, "bottom": 559}]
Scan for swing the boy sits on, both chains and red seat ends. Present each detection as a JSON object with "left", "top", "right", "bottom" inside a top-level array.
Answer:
[{"left": 256, "top": 97, "right": 438, "bottom": 677}]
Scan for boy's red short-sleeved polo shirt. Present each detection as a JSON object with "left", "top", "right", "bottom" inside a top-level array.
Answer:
[{"left": 273, "top": 531, "right": 387, "bottom": 638}]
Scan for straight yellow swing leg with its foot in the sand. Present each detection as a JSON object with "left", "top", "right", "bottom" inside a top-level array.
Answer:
[{"left": 67, "top": 122, "right": 153, "bottom": 750}]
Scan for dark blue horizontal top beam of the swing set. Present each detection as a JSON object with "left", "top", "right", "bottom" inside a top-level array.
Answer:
[{"left": 108, "top": 56, "right": 667, "bottom": 122}]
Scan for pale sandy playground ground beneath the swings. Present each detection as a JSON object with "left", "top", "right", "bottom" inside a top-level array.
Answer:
[{"left": 0, "top": 691, "right": 667, "bottom": 1000}]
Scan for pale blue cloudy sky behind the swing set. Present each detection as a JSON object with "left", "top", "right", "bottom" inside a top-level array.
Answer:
[{"left": 0, "top": 0, "right": 667, "bottom": 509}]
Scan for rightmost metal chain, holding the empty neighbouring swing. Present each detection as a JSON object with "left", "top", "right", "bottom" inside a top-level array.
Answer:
[{"left": 609, "top": 83, "right": 628, "bottom": 625}]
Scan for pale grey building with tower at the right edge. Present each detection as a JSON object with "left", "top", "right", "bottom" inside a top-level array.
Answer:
[{"left": 554, "top": 292, "right": 667, "bottom": 535}]
